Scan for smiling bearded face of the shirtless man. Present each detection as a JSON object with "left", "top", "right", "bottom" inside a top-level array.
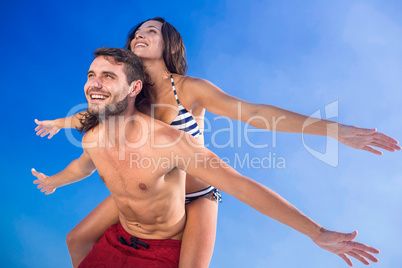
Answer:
[{"left": 84, "top": 56, "right": 130, "bottom": 118}]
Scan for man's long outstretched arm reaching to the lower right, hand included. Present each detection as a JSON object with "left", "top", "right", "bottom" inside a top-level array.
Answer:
[{"left": 179, "top": 146, "right": 379, "bottom": 266}]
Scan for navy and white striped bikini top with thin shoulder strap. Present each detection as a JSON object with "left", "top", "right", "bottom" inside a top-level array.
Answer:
[{"left": 170, "top": 74, "right": 201, "bottom": 138}]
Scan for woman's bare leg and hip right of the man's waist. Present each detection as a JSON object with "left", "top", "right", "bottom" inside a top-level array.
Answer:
[{"left": 179, "top": 176, "right": 218, "bottom": 268}]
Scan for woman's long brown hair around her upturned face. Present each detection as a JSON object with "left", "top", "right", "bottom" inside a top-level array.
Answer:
[{"left": 125, "top": 17, "right": 187, "bottom": 75}]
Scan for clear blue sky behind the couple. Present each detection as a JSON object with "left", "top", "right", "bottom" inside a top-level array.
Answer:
[{"left": 0, "top": 0, "right": 402, "bottom": 268}]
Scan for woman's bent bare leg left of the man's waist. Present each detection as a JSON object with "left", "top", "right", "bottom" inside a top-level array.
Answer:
[{"left": 66, "top": 196, "right": 119, "bottom": 267}]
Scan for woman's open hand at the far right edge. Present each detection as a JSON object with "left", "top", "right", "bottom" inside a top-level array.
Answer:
[{"left": 338, "top": 125, "right": 401, "bottom": 155}]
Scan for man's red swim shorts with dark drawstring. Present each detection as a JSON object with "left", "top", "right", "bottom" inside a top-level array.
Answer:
[{"left": 78, "top": 223, "right": 181, "bottom": 268}]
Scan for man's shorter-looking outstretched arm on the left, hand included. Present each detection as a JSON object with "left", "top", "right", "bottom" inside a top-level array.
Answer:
[{"left": 31, "top": 150, "right": 96, "bottom": 194}]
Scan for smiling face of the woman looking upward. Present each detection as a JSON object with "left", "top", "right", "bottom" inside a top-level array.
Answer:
[{"left": 130, "top": 20, "right": 163, "bottom": 60}]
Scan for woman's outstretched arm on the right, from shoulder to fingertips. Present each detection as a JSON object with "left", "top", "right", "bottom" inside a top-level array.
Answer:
[{"left": 182, "top": 77, "right": 401, "bottom": 155}]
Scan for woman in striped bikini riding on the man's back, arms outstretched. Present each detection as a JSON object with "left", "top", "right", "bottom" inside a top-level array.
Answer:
[{"left": 36, "top": 18, "right": 400, "bottom": 267}]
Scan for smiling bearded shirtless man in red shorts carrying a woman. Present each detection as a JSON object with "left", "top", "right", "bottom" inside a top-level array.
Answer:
[{"left": 32, "top": 48, "right": 379, "bottom": 267}]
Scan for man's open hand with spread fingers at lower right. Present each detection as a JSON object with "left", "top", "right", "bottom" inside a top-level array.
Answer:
[{"left": 313, "top": 228, "right": 380, "bottom": 266}]
